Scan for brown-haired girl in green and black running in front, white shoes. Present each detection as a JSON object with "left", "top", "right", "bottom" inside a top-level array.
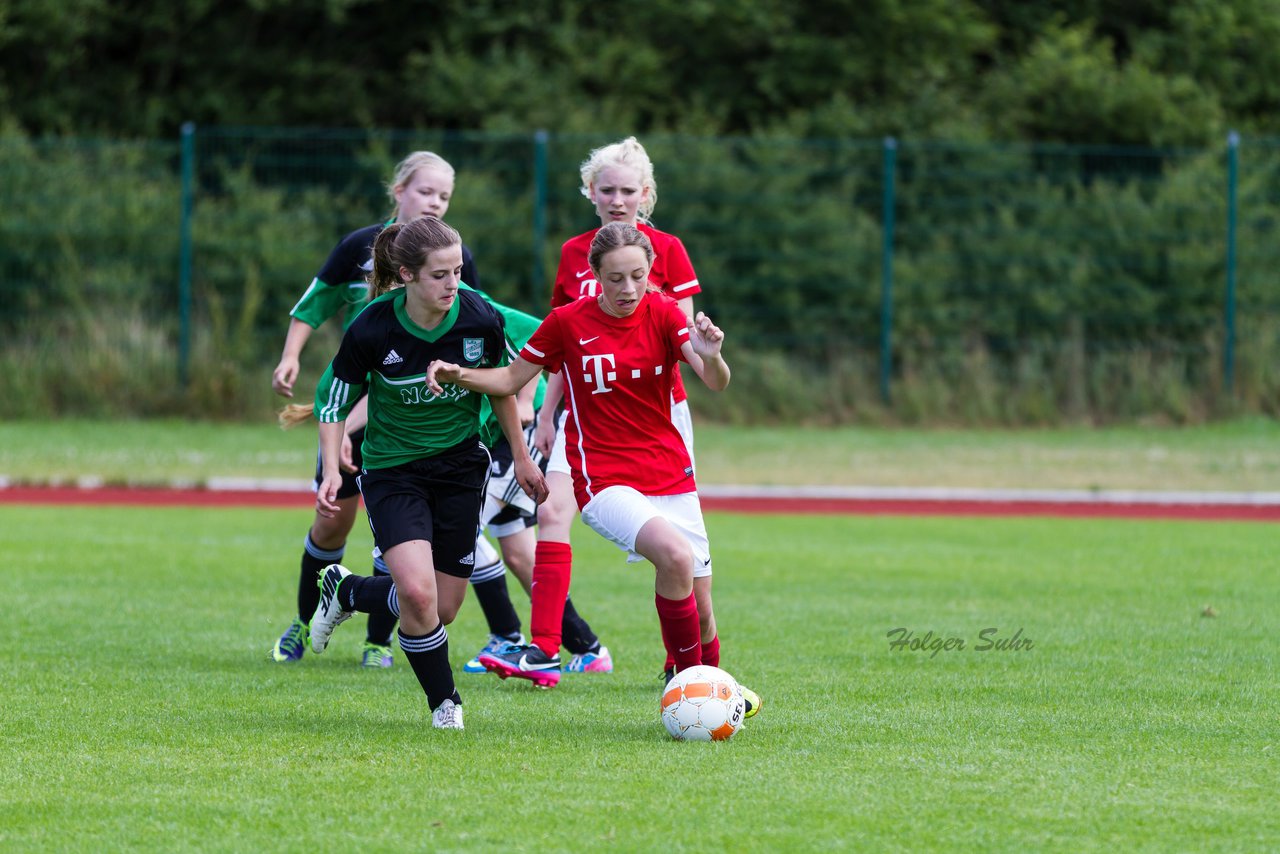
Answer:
[{"left": 311, "top": 216, "right": 547, "bottom": 729}]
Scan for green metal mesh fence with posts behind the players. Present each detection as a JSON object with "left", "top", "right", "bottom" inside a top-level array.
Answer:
[{"left": 0, "top": 125, "right": 1280, "bottom": 423}]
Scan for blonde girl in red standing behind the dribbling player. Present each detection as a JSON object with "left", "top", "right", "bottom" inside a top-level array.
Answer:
[{"left": 530, "top": 137, "right": 716, "bottom": 684}]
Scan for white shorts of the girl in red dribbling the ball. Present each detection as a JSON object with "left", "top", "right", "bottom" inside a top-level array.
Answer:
[{"left": 582, "top": 487, "right": 712, "bottom": 579}]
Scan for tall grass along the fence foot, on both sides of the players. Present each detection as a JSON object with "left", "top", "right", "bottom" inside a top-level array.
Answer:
[{"left": 0, "top": 323, "right": 1280, "bottom": 428}]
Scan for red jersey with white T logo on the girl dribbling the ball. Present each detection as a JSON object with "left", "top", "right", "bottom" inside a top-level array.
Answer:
[{"left": 520, "top": 291, "right": 698, "bottom": 508}]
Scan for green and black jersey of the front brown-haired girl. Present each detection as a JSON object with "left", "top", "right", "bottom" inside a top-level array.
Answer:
[{"left": 315, "top": 288, "right": 516, "bottom": 469}]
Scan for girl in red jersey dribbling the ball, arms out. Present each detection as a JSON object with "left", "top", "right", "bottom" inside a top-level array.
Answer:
[{"left": 426, "top": 222, "right": 760, "bottom": 716}]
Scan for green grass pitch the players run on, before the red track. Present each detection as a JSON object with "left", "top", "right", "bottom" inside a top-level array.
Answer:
[{"left": 0, "top": 506, "right": 1280, "bottom": 851}]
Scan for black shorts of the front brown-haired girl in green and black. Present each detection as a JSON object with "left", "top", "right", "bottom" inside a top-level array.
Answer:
[{"left": 358, "top": 438, "right": 489, "bottom": 579}]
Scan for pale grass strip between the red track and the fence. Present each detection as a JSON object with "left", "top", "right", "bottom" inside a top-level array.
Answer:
[{"left": 0, "top": 419, "right": 1280, "bottom": 490}]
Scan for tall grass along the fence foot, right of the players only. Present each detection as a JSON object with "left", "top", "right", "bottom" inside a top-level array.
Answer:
[{"left": 687, "top": 334, "right": 1254, "bottom": 428}]
